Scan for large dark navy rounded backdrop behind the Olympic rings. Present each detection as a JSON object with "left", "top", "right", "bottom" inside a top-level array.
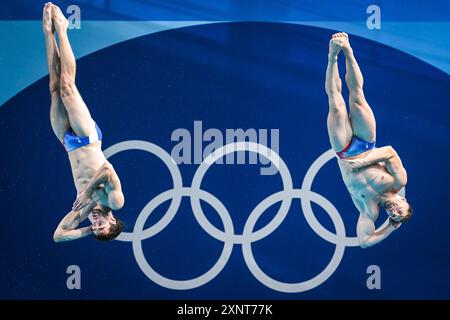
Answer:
[{"left": 0, "top": 1, "right": 450, "bottom": 299}]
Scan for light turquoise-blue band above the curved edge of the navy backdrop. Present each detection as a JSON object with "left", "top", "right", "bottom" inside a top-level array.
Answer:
[{"left": 0, "top": 20, "right": 450, "bottom": 107}]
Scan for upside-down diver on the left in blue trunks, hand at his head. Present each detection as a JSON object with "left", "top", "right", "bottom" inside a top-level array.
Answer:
[{"left": 42, "top": 2, "right": 124, "bottom": 242}]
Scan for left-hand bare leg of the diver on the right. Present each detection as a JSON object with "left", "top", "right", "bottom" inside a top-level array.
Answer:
[{"left": 325, "top": 36, "right": 353, "bottom": 152}]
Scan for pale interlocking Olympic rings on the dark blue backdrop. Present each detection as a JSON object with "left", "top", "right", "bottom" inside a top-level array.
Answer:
[{"left": 104, "top": 140, "right": 388, "bottom": 293}]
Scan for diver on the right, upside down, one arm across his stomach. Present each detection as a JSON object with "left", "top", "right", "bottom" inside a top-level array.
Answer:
[{"left": 325, "top": 32, "right": 412, "bottom": 248}]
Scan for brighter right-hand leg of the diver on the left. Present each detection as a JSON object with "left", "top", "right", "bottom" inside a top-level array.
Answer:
[{"left": 52, "top": 5, "right": 95, "bottom": 136}]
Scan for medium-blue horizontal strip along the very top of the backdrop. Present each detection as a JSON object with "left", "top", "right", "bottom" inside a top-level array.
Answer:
[{"left": 0, "top": 0, "right": 449, "bottom": 21}]
